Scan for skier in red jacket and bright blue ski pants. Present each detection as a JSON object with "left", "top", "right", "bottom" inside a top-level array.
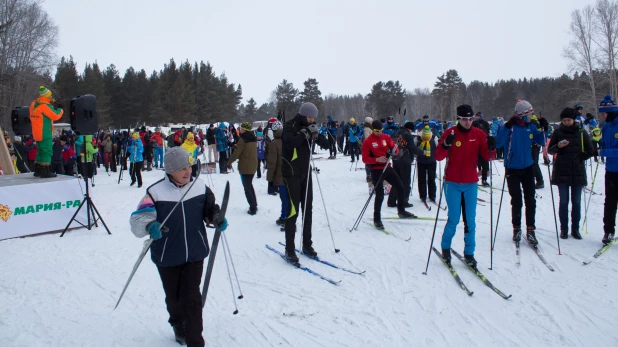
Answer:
[{"left": 436, "top": 105, "right": 489, "bottom": 267}]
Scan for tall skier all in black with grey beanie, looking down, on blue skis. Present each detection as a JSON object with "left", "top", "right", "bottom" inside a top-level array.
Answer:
[{"left": 281, "top": 102, "right": 329, "bottom": 264}]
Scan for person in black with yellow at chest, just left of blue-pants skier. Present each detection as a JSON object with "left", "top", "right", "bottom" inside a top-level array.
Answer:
[{"left": 414, "top": 122, "right": 437, "bottom": 203}]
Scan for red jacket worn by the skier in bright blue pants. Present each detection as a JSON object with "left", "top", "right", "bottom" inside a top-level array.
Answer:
[{"left": 436, "top": 126, "right": 489, "bottom": 184}]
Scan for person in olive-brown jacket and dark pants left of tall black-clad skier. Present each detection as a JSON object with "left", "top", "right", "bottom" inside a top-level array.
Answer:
[{"left": 227, "top": 122, "right": 258, "bottom": 216}]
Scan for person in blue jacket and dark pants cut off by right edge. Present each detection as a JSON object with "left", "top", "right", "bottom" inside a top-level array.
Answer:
[{"left": 599, "top": 94, "right": 618, "bottom": 244}]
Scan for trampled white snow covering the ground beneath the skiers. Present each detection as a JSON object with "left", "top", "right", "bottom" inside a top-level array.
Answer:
[{"left": 0, "top": 154, "right": 618, "bottom": 347}]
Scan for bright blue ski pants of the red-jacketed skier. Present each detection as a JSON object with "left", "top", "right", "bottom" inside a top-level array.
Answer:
[{"left": 441, "top": 181, "right": 478, "bottom": 255}]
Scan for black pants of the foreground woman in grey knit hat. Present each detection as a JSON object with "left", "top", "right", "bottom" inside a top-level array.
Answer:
[{"left": 157, "top": 260, "right": 205, "bottom": 347}]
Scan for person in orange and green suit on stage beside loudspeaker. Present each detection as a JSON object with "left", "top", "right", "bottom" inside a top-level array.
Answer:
[{"left": 30, "top": 86, "right": 64, "bottom": 178}]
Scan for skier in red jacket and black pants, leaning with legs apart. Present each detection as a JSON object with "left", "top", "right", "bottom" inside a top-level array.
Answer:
[{"left": 362, "top": 119, "right": 416, "bottom": 229}]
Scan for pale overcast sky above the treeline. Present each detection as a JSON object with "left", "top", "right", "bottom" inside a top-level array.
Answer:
[{"left": 43, "top": 0, "right": 593, "bottom": 104}]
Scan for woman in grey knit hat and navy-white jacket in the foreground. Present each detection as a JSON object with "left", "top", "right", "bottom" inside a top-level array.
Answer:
[{"left": 130, "top": 147, "right": 228, "bottom": 347}]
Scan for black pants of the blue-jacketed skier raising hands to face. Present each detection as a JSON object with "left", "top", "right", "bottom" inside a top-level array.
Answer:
[{"left": 506, "top": 165, "right": 536, "bottom": 228}]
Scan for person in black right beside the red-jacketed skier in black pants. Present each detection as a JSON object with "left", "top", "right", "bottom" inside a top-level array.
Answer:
[{"left": 388, "top": 122, "right": 423, "bottom": 207}]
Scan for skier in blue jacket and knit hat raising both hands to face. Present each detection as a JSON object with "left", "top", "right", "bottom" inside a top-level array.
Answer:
[{"left": 496, "top": 100, "right": 544, "bottom": 246}]
